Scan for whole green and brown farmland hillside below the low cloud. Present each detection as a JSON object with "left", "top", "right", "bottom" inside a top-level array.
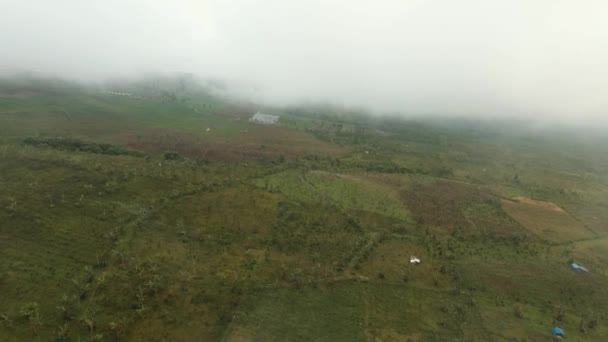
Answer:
[{"left": 0, "top": 79, "right": 608, "bottom": 341}]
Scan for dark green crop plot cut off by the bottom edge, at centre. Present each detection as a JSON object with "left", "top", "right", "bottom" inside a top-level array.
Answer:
[{"left": 225, "top": 281, "right": 461, "bottom": 341}]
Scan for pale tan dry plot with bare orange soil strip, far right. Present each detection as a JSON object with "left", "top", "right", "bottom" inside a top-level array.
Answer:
[{"left": 502, "top": 199, "right": 594, "bottom": 242}]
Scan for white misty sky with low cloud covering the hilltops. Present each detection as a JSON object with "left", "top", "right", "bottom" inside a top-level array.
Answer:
[{"left": 0, "top": 0, "right": 608, "bottom": 120}]
